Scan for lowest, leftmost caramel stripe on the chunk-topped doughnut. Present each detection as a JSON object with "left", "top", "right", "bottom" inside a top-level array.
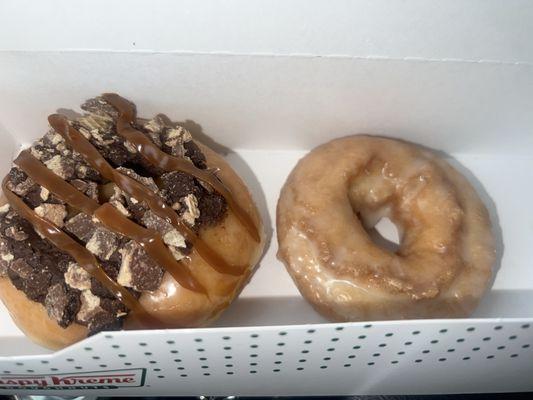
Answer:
[{"left": 2, "top": 177, "right": 159, "bottom": 327}]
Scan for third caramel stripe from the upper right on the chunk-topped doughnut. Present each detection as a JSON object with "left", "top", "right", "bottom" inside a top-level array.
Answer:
[{"left": 14, "top": 150, "right": 205, "bottom": 293}]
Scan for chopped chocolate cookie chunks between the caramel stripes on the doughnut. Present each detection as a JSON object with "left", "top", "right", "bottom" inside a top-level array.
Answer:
[{"left": 0, "top": 98, "right": 227, "bottom": 334}]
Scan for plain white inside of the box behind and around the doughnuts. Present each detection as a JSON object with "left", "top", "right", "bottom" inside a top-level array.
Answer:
[{"left": 0, "top": 1, "right": 533, "bottom": 355}]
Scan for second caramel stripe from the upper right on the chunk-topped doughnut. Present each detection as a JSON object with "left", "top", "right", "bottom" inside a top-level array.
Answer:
[{"left": 48, "top": 114, "right": 245, "bottom": 276}]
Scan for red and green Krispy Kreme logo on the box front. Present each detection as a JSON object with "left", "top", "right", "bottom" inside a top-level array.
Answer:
[{"left": 0, "top": 368, "right": 146, "bottom": 390}]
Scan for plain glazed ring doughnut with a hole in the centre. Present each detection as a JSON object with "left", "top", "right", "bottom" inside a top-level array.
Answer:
[{"left": 277, "top": 135, "right": 495, "bottom": 321}]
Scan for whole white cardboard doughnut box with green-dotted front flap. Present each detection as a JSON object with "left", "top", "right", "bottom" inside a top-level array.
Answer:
[{"left": 0, "top": 0, "right": 533, "bottom": 396}]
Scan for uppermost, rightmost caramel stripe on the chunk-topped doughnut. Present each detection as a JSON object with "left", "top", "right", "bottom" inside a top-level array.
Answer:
[{"left": 102, "top": 93, "right": 261, "bottom": 244}]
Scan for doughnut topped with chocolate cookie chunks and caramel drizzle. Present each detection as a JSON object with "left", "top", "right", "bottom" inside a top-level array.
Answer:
[{"left": 0, "top": 94, "right": 264, "bottom": 349}]
